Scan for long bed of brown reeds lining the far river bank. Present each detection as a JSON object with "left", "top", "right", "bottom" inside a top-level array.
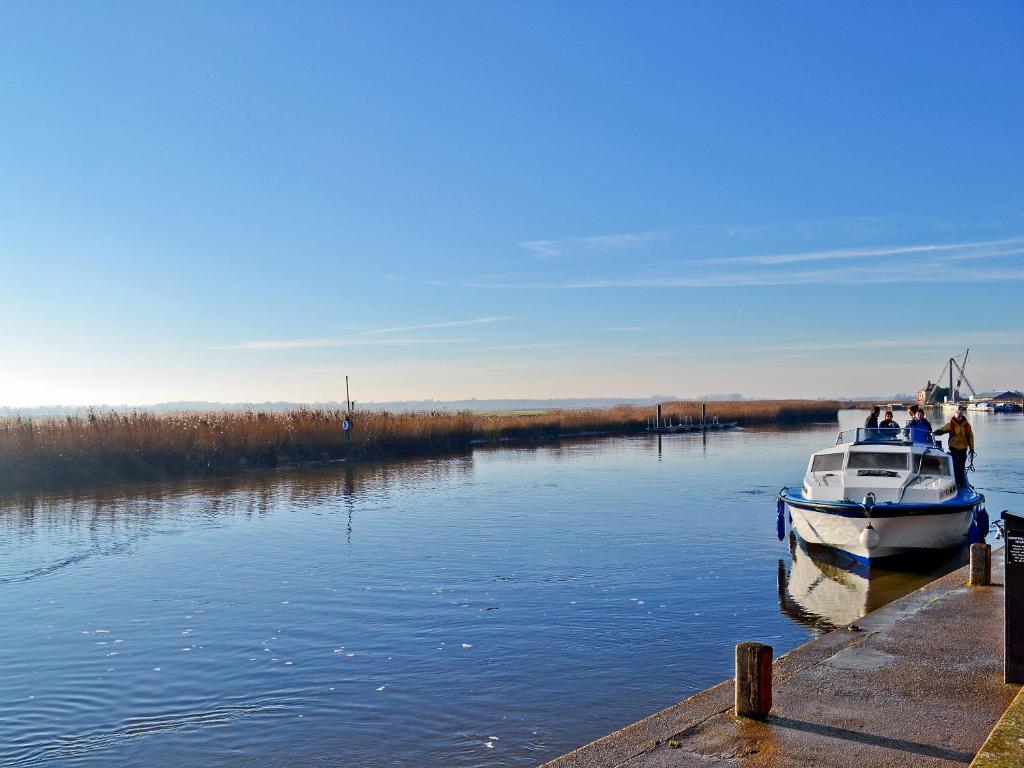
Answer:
[{"left": 0, "top": 400, "right": 841, "bottom": 488}]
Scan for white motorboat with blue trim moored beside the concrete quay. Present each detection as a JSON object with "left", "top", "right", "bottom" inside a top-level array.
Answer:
[{"left": 778, "top": 428, "right": 988, "bottom": 562}]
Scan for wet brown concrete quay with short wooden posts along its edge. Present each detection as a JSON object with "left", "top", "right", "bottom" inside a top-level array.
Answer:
[{"left": 544, "top": 550, "right": 1024, "bottom": 768}]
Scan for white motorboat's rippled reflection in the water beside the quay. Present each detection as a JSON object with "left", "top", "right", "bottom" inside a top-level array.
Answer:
[{"left": 778, "top": 532, "right": 969, "bottom": 632}]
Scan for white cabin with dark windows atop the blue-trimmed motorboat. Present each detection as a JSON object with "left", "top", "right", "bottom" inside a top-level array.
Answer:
[{"left": 803, "top": 428, "right": 956, "bottom": 504}]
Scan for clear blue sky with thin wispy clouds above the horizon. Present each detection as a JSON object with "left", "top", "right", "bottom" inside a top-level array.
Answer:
[{"left": 0, "top": 0, "right": 1024, "bottom": 407}]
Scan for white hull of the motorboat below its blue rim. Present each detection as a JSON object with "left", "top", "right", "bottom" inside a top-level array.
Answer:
[{"left": 786, "top": 504, "right": 974, "bottom": 560}]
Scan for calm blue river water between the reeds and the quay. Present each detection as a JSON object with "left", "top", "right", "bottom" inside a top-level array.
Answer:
[{"left": 0, "top": 413, "right": 1024, "bottom": 766}]
